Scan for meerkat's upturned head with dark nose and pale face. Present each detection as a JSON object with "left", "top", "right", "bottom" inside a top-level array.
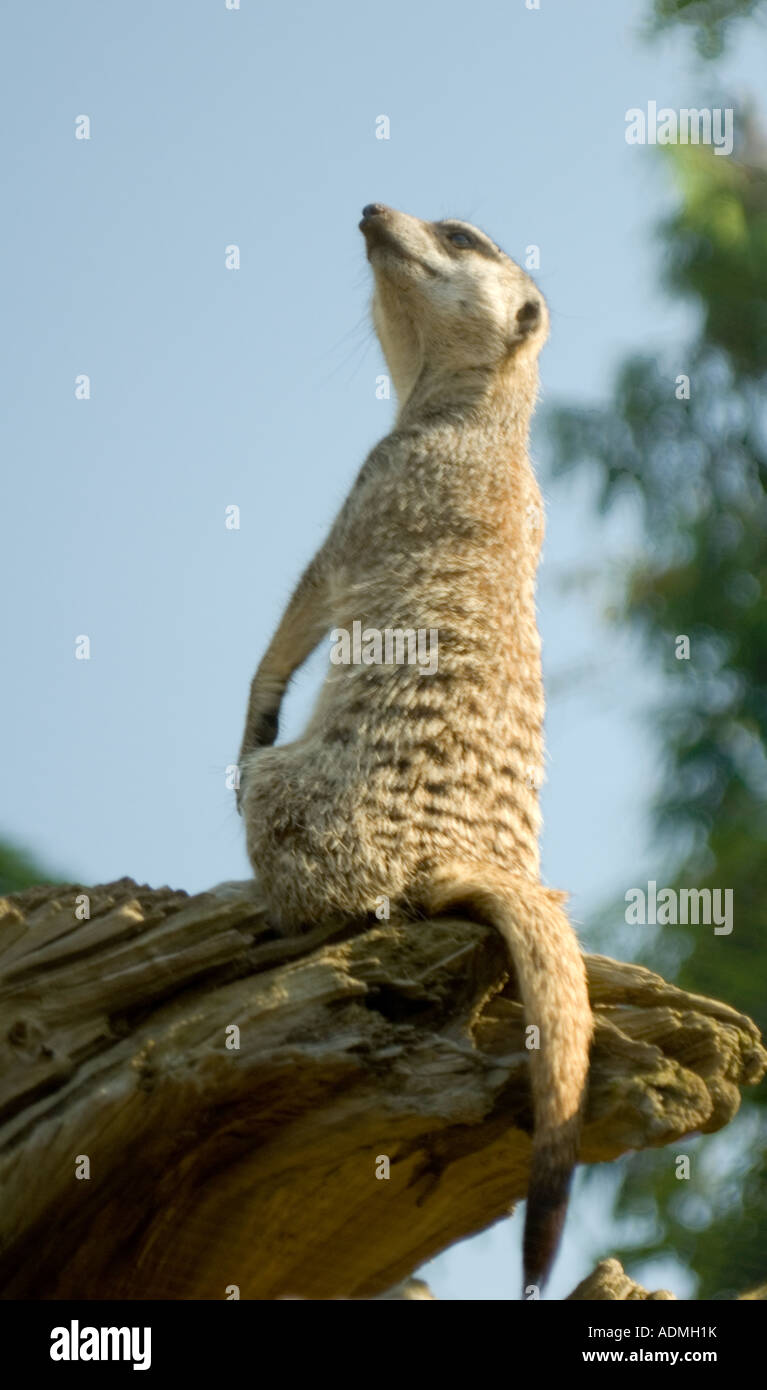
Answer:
[{"left": 360, "top": 203, "right": 549, "bottom": 404}]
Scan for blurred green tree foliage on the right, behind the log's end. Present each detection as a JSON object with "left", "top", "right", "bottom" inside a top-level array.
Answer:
[{"left": 547, "top": 135, "right": 767, "bottom": 1298}]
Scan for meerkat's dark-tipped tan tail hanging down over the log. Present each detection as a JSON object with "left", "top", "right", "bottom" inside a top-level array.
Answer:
[{"left": 425, "top": 863, "right": 593, "bottom": 1289}]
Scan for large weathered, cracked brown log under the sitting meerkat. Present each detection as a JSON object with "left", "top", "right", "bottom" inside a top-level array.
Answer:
[{"left": 0, "top": 878, "right": 767, "bottom": 1298}]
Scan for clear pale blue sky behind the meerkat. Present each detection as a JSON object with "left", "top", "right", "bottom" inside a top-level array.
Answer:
[{"left": 0, "top": 0, "right": 764, "bottom": 1298}]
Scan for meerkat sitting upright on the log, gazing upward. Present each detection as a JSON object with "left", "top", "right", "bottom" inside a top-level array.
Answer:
[{"left": 238, "top": 203, "right": 592, "bottom": 1287}]
